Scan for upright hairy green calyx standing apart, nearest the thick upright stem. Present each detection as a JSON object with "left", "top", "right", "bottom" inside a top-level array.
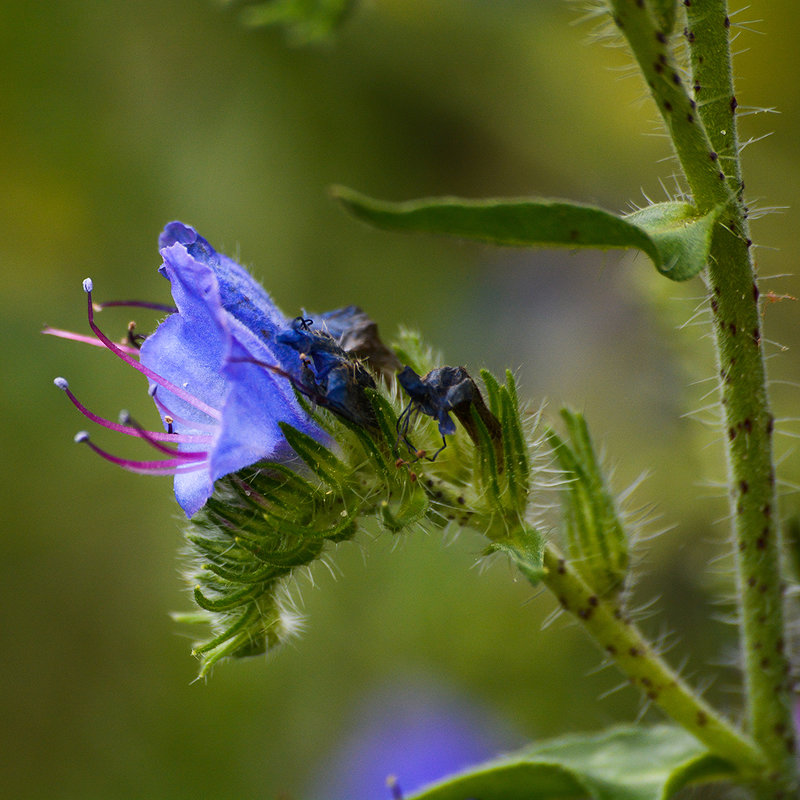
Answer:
[{"left": 547, "top": 409, "right": 629, "bottom": 596}]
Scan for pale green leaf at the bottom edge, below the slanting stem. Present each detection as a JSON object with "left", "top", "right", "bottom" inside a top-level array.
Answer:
[{"left": 409, "top": 725, "right": 735, "bottom": 800}]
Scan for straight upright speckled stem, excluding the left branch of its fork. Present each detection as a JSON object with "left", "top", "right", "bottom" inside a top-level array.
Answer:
[{"left": 686, "top": 0, "right": 797, "bottom": 796}]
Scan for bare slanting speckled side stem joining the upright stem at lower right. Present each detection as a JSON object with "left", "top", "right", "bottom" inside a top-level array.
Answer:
[{"left": 542, "top": 544, "right": 765, "bottom": 778}]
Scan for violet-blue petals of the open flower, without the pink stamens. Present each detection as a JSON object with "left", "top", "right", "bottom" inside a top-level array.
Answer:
[{"left": 140, "top": 222, "right": 325, "bottom": 516}]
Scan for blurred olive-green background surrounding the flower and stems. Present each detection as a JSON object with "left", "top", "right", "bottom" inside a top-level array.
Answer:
[{"left": 0, "top": 0, "right": 800, "bottom": 800}]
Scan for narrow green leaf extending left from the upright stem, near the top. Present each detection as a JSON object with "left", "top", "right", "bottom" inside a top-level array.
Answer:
[{"left": 332, "top": 186, "right": 721, "bottom": 281}]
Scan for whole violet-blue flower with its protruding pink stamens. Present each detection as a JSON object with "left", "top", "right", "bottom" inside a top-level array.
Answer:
[{"left": 47, "top": 222, "right": 326, "bottom": 517}]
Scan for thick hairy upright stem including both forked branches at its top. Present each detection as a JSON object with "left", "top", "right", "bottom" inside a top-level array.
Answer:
[{"left": 610, "top": 0, "right": 798, "bottom": 797}]
